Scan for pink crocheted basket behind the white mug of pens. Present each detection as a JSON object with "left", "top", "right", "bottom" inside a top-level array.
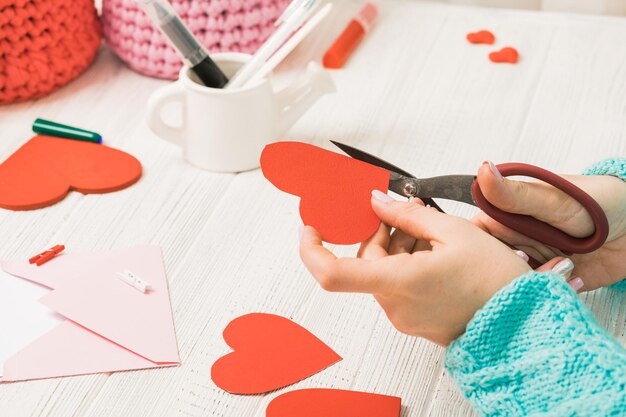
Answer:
[{"left": 102, "top": 0, "right": 290, "bottom": 79}]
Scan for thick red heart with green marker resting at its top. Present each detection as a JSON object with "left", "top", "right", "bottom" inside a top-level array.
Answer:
[{"left": 0, "top": 136, "right": 141, "bottom": 210}]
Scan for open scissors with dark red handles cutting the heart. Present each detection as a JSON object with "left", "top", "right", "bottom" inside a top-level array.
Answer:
[{"left": 331, "top": 140, "right": 609, "bottom": 255}]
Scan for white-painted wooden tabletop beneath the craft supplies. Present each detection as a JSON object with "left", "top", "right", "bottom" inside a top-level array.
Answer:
[{"left": 0, "top": 1, "right": 626, "bottom": 417}]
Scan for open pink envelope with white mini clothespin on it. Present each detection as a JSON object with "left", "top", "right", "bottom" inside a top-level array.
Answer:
[{"left": 0, "top": 246, "right": 180, "bottom": 382}]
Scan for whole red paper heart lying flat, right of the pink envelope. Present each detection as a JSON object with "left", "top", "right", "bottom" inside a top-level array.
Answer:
[{"left": 211, "top": 313, "right": 341, "bottom": 394}]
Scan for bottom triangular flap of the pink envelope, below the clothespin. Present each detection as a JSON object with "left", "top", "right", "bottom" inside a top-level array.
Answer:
[{"left": 0, "top": 321, "right": 176, "bottom": 382}]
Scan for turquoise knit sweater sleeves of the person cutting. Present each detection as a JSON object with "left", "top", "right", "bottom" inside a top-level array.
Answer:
[{"left": 446, "top": 158, "right": 626, "bottom": 417}]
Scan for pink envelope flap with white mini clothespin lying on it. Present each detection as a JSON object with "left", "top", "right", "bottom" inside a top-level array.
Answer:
[{"left": 3, "top": 246, "right": 179, "bottom": 363}]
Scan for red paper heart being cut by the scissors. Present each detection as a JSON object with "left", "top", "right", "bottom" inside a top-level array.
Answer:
[{"left": 261, "top": 142, "right": 389, "bottom": 245}]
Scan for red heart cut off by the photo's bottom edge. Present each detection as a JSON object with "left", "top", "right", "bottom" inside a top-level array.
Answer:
[{"left": 265, "top": 388, "right": 401, "bottom": 417}]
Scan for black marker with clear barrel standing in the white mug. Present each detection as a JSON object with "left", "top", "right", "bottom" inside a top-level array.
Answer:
[{"left": 137, "top": 0, "right": 228, "bottom": 88}]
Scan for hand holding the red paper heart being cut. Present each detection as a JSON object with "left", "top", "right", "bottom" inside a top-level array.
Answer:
[{"left": 300, "top": 191, "right": 530, "bottom": 346}]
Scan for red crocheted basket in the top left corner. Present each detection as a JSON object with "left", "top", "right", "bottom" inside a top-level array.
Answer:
[{"left": 0, "top": 0, "right": 101, "bottom": 104}]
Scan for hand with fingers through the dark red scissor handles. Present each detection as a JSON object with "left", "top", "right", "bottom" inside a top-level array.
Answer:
[{"left": 472, "top": 162, "right": 626, "bottom": 291}]
